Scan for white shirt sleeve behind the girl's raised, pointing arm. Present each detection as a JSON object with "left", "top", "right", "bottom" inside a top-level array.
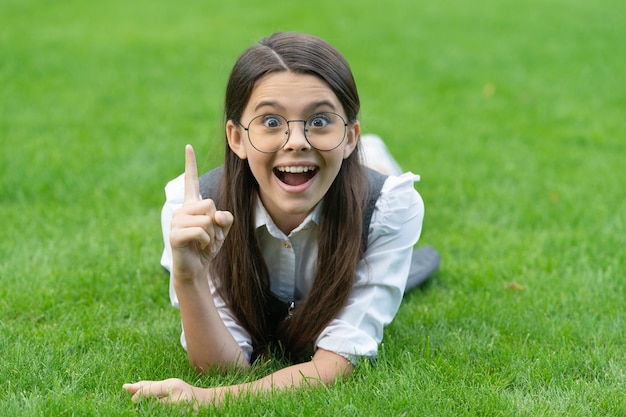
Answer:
[{"left": 161, "top": 174, "right": 253, "bottom": 361}]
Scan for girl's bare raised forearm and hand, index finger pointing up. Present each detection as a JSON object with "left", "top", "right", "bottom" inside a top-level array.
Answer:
[{"left": 169, "top": 146, "right": 248, "bottom": 370}]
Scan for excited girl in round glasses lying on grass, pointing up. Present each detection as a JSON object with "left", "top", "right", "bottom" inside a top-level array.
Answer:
[{"left": 124, "top": 33, "right": 432, "bottom": 404}]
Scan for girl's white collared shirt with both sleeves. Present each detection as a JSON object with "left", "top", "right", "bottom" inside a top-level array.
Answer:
[{"left": 161, "top": 173, "right": 424, "bottom": 363}]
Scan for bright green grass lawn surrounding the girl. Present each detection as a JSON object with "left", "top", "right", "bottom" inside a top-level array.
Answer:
[{"left": 0, "top": 0, "right": 626, "bottom": 416}]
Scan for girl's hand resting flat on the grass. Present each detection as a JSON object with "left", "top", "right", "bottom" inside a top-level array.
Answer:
[{"left": 122, "top": 378, "right": 206, "bottom": 404}]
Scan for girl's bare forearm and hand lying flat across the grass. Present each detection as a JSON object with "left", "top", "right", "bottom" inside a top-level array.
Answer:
[{"left": 124, "top": 349, "right": 353, "bottom": 405}]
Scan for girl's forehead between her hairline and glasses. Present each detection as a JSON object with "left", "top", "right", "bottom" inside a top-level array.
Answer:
[{"left": 246, "top": 71, "right": 343, "bottom": 113}]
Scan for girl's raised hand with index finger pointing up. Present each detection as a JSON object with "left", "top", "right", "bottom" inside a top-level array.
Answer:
[{"left": 170, "top": 145, "right": 233, "bottom": 280}]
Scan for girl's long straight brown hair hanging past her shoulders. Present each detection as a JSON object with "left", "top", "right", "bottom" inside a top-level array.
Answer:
[{"left": 211, "top": 33, "right": 367, "bottom": 353}]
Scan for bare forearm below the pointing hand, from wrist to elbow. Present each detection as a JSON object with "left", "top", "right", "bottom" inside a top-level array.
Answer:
[{"left": 174, "top": 279, "right": 249, "bottom": 371}]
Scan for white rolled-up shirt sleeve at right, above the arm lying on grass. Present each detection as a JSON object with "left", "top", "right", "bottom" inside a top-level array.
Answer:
[{"left": 316, "top": 173, "right": 424, "bottom": 363}]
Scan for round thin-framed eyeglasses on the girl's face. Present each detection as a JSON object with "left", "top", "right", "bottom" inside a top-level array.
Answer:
[{"left": 239, "top": 112, "right": 348, "bottom": 153}]
